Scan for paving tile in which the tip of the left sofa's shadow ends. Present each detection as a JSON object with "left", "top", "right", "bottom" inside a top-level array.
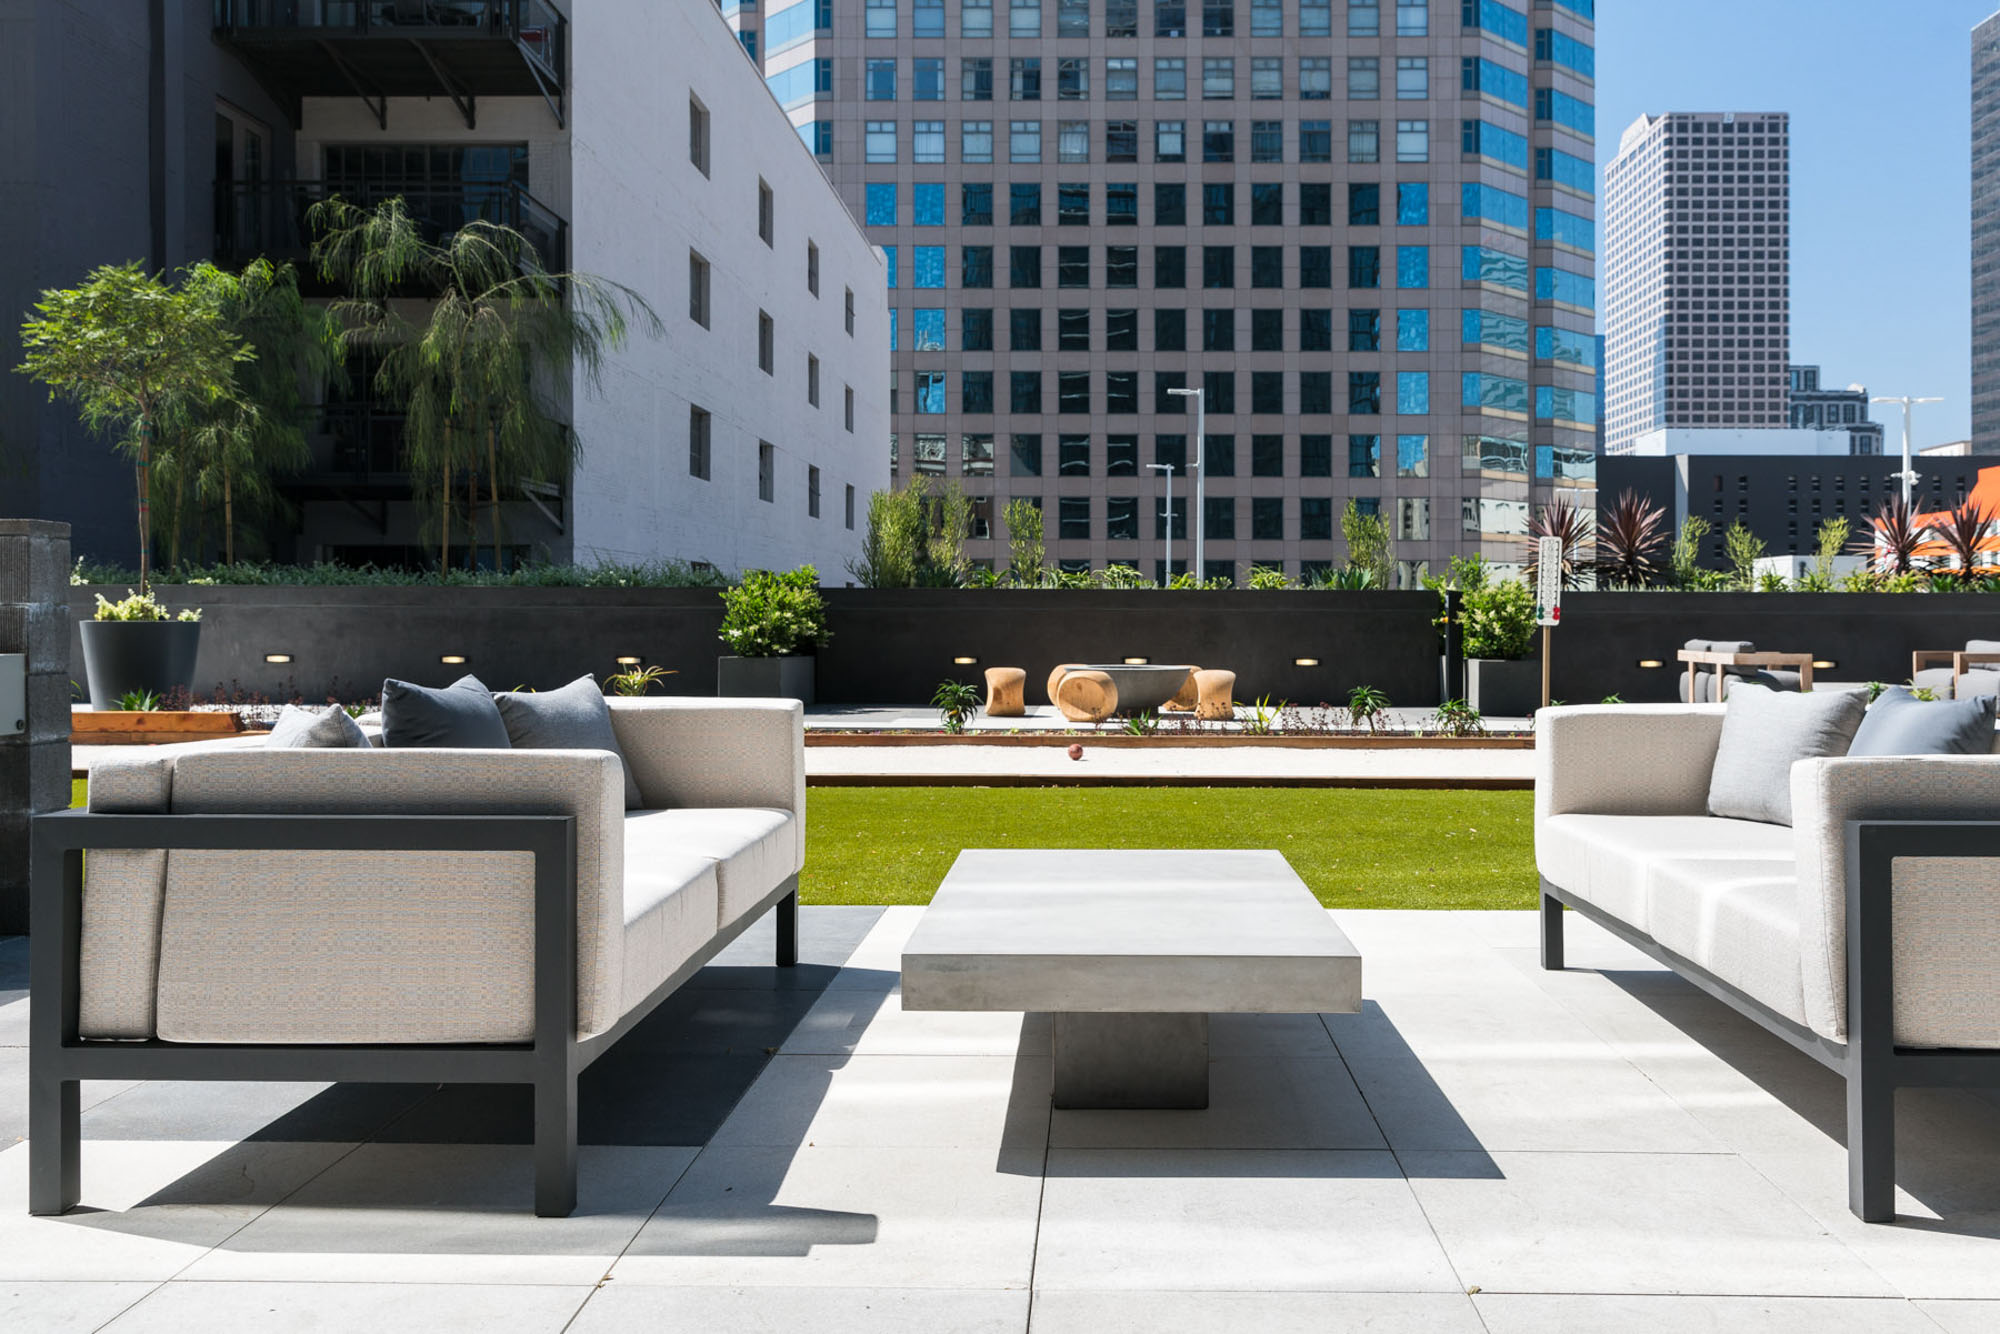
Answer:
[{"left": 612, "top": 1146, "right": 1042, "bottom": 1288}]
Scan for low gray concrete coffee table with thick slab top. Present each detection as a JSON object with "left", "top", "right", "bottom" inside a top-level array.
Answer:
[{"left": 902, "top": 850, "right": 1362, "bottom": 1108}]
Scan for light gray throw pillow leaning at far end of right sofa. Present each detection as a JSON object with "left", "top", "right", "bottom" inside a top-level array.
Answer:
[{"left": 1708, "top": 682, "right": 1868, "bottom": 824}]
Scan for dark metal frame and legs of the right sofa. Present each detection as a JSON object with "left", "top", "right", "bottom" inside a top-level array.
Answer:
[{"left": 1542, "top": 820, "right": 2000, "bottom": 1222}]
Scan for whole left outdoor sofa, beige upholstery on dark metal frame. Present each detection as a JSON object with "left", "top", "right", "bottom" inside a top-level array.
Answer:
[{"left": 30, "top": 698, "right": 806, "bottom": 1216}]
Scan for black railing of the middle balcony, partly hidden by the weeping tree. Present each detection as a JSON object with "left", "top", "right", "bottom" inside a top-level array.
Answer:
[{"left": 216, "top": 180, "right": 568, "bottom": 282}]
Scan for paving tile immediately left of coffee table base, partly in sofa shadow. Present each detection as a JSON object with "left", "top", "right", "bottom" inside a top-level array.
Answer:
[{"left": 708, "top": 1056, "right": 1050, "bottom": 1150}]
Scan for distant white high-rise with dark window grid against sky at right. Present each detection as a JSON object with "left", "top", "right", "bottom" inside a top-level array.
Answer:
[{"left": 1604, "top": 112, "right": 1792, "bottom": 454}]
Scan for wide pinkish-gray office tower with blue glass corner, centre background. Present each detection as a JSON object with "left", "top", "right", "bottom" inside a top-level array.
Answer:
[{"left": 722, "top": 0, "right": 1592, "bottom": 580}]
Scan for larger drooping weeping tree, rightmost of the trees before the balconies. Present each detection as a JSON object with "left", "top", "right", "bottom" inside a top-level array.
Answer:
[{"left": 308, "top": 196, "right": 666, "bottom": 570}]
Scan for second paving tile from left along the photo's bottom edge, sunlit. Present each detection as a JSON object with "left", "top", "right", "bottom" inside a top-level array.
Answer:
[{"left": 106, "top": 1282, "right": 594, "bottom": 1334}]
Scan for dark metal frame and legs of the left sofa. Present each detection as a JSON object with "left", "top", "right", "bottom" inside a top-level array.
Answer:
[{"left": 28, "top": 810, "right": 798, "bottom": 1218}]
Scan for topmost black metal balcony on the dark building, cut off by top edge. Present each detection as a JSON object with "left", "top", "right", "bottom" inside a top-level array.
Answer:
[{"left": 214, "top": 0, "right": 570, "bottom": 130}]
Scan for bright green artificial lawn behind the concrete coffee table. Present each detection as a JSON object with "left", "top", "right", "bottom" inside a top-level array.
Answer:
[{"left": 72, "top": 780, "right": 1538, "bottom": 908}]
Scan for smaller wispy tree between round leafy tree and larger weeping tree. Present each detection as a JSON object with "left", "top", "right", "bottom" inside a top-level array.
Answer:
[{"left": 160, "top": 260, "right": 346, "bottom": 564}]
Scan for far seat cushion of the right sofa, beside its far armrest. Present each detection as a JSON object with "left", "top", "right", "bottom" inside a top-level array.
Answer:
[{"left": 1534, "top": 814, "right": 1792, "bottom": 934}]
